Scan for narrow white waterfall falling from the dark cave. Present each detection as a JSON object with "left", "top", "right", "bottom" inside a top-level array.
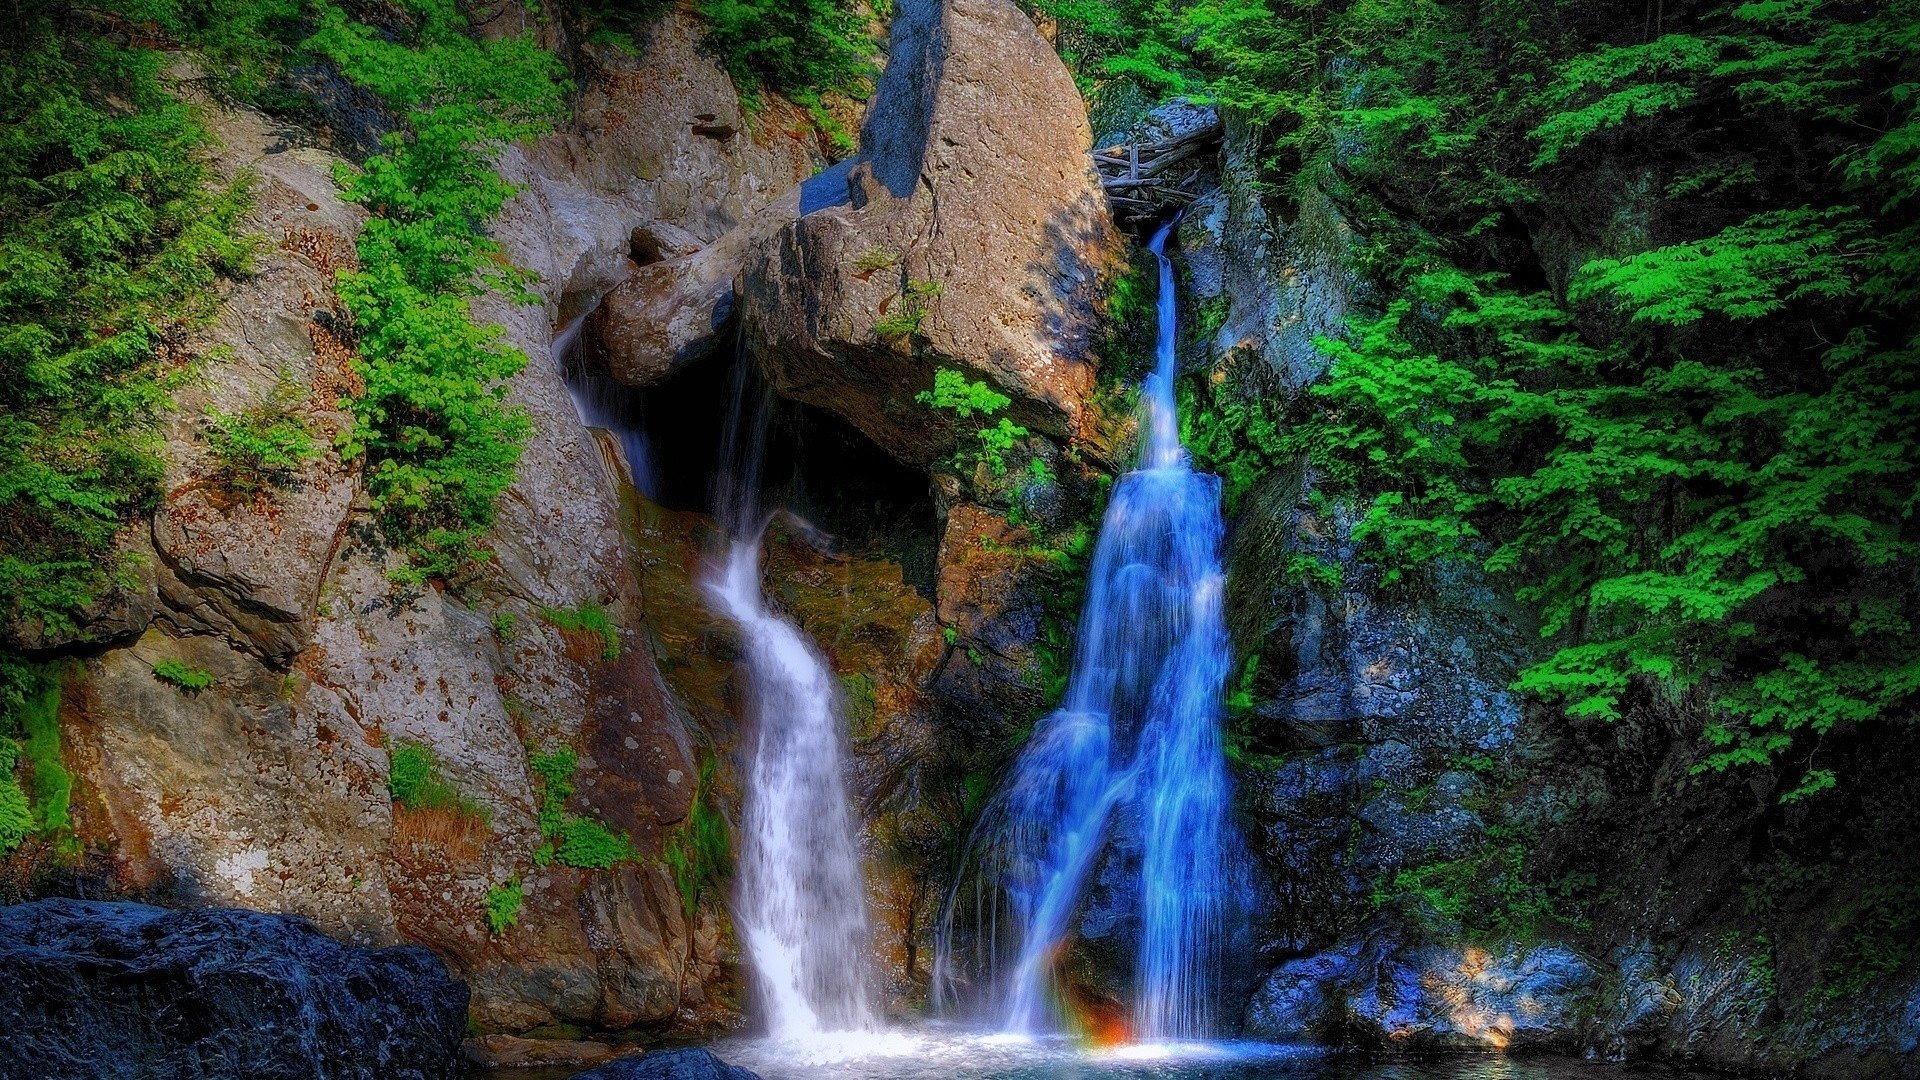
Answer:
[{"left": 703, "top": 357, "right": 877, "bottom": 1040}]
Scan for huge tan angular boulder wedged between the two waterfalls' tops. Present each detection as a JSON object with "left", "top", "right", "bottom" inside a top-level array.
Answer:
[{"left": 743, "top": 0, "right": 1117, "bottom": 465}]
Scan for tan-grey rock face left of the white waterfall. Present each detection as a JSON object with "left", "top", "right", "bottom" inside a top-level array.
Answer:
[{"left": 41, "top": 12, "right": 818, "bottom": 1032}]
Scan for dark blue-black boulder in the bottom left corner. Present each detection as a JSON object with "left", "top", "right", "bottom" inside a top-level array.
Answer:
[{"left": 0, "top": 899, "right": 467, "bottom": 1080}]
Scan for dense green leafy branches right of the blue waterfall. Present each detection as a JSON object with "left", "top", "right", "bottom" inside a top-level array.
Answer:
[{"left": 1090, "top": 0, "right": 1920, "bottom": 807}]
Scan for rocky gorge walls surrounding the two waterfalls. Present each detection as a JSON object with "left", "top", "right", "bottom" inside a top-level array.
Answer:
[{"left": 0, "top": 0, "right": 1920, "bottom": 1076}]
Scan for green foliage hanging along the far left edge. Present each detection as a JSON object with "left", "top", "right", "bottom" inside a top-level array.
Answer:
[{"left": 0, "top": 12, "right": 248, "bottom": 634}]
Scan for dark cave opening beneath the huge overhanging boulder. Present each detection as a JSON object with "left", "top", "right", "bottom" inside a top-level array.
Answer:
[{"left": 566, "top": 311, "right": 939, "bottom": 598}]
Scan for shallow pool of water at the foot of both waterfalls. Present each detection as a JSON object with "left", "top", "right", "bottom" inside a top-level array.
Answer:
[{"left": 486, "top": 1028, "right": 1699, "bottom": 1080}]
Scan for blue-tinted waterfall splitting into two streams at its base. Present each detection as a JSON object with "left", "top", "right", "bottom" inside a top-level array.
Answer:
[{"left": 937, "top": 225, "right": 1240, "bottom": 1040}]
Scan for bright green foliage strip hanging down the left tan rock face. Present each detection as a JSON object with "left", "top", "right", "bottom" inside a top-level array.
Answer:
[{"left": 307, "top": 0, "right": 564, "bottom": 582}]
